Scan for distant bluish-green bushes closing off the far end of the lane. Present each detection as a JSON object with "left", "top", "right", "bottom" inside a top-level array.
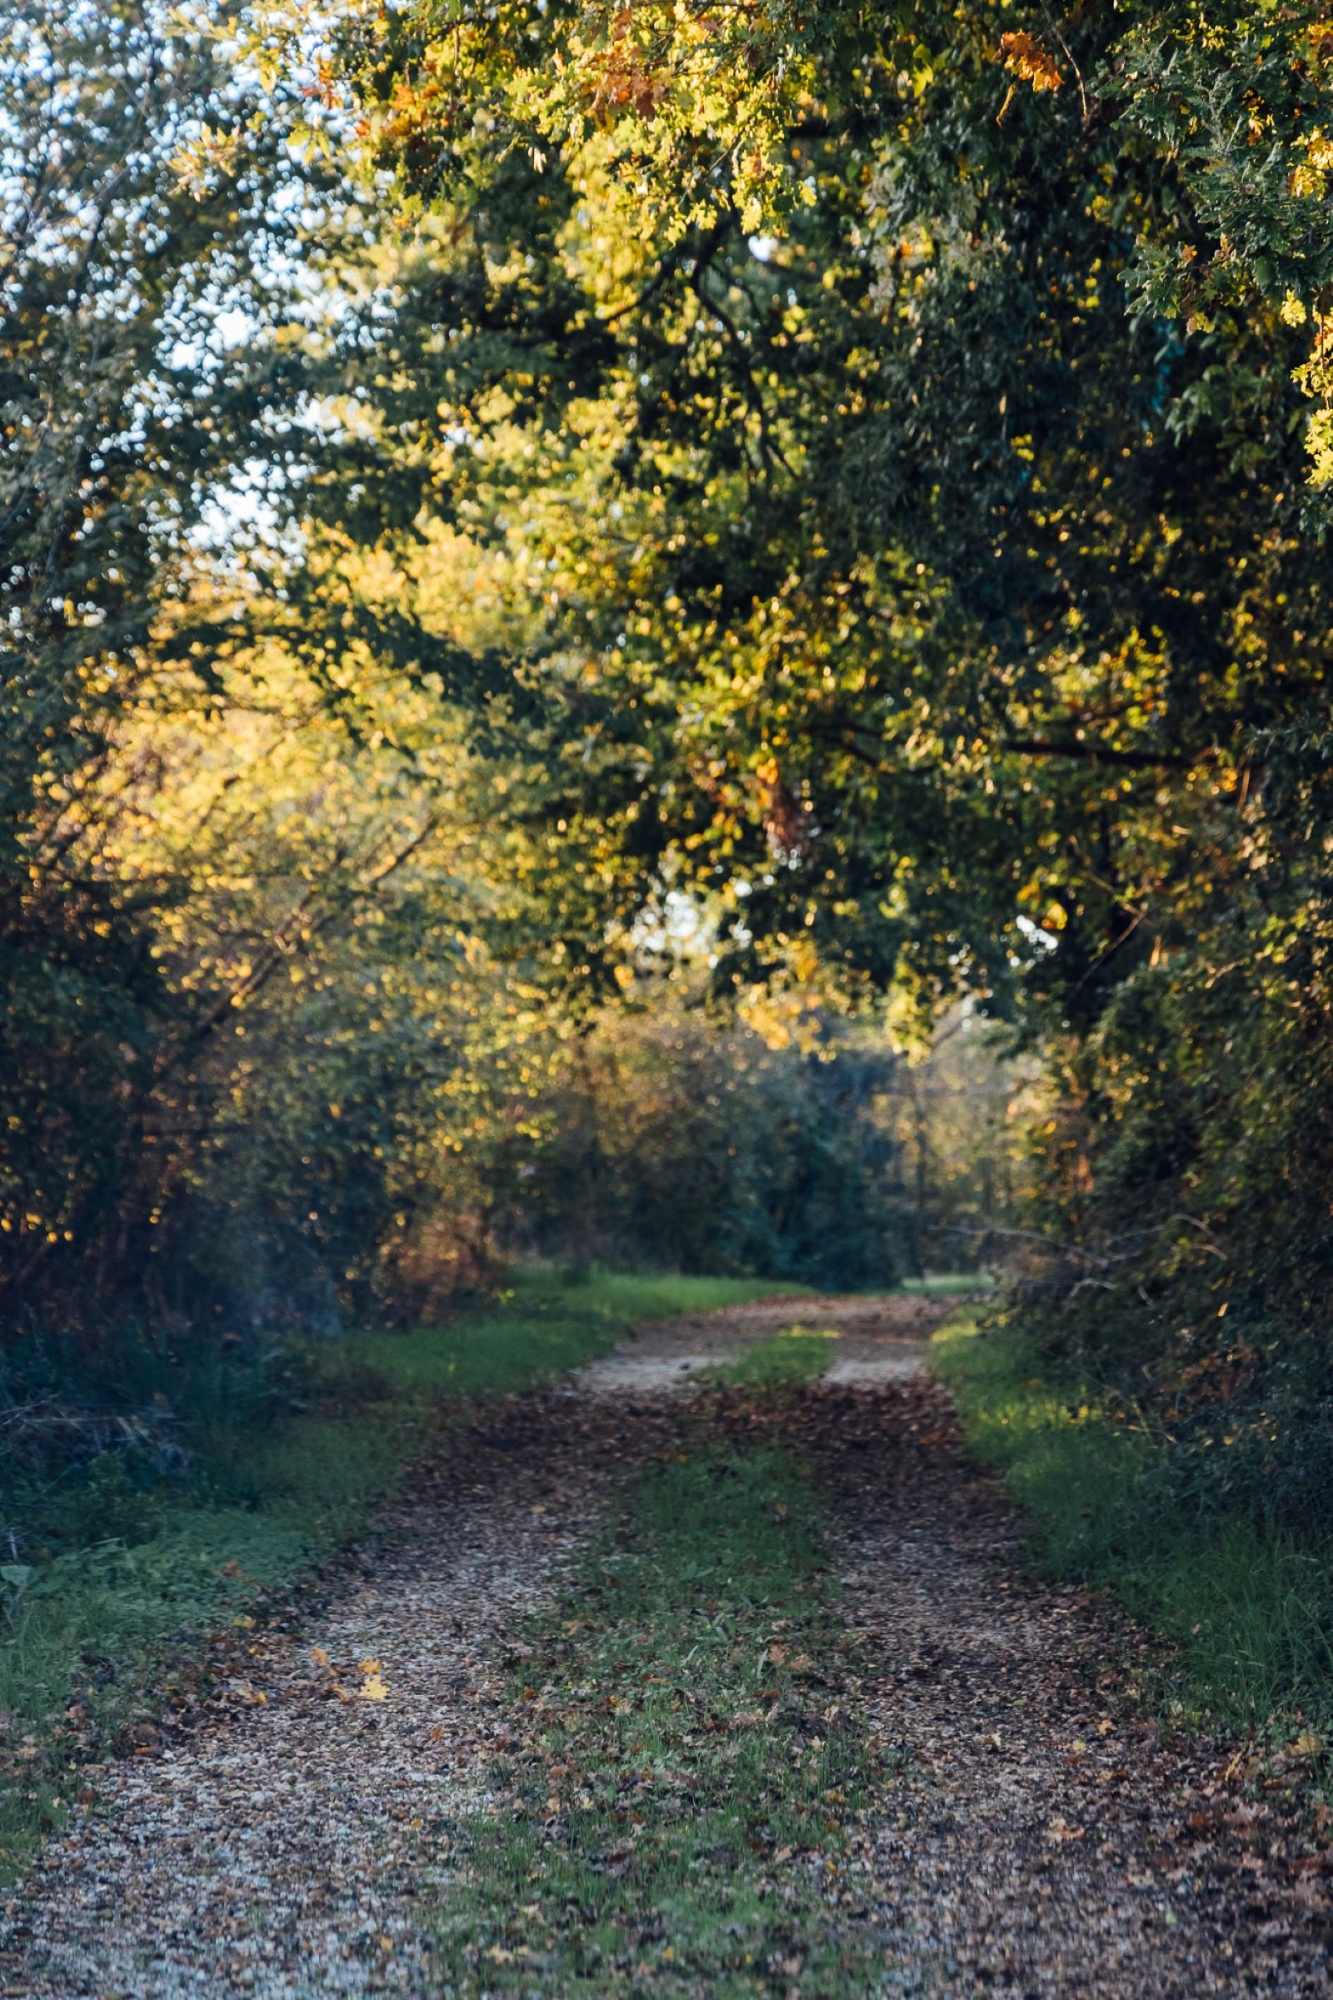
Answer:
[{"left": 510, "top": 1006, "right": 1016, "bottom": 1292}]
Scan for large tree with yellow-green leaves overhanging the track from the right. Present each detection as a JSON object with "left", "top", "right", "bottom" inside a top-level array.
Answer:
[{"left": 324, "top": 4, "right": 1333, "bottom": 1472}]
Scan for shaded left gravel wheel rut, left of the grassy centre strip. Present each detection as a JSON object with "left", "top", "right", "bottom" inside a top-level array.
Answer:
[{"left": 0, "top": 1392, "right": 652, "bottom": 2000}]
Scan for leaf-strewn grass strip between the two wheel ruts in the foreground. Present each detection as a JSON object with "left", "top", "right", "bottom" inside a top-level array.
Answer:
[{"left": 434, "top": 1418, "right": 883, "bottom": 2000}]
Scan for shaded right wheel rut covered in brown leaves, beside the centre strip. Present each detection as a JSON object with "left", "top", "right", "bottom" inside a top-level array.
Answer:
[{"left": 791, "top": 1378, "right": 1333, "bottom": 2000}]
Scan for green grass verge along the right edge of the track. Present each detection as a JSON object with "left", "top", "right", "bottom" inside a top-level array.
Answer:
[{"left": 933, "top": 1314, "right": 1333, "bottom": 1738}]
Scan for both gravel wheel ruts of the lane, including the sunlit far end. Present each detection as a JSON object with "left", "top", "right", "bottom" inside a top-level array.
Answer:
[{"left": 0, "top": 1300, "right": 1333, "bottom": 2000}]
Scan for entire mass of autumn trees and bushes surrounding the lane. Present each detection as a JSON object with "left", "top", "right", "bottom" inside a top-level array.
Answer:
[{"left": 0, "top": 0, "right": 1333, "bottom": 1516}]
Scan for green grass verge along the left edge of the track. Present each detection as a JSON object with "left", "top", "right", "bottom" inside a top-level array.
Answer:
[{"left": 0, "top": 1270, "right": 788, "bottom": 1882}]
